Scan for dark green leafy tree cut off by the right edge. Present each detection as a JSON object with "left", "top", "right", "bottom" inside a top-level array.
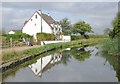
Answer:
[{"left": 109, "top": 13, "right": 120, "bottom": 38}]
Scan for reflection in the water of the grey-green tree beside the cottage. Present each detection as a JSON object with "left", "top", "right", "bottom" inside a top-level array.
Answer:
[{"left": 61, "top": 51, "right": 71, "bottom": 65}]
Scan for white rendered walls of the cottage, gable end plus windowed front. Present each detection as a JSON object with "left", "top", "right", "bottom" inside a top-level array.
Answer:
[{"left": 22, "top": 11, "right": 62, "bottom": 39}]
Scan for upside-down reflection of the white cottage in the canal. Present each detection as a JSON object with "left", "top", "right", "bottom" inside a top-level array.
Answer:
[{"left": 29, "top": 53, "right": 62, "bottom": 77}]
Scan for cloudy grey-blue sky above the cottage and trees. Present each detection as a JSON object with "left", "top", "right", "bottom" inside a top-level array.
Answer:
[{"left": 2, "top": 2, "right": 118, "bottom": 34}]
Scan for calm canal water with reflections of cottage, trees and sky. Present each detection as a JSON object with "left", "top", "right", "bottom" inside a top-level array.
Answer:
[{"left": 2, "top": 46, "right": 120, "bottom": 82}]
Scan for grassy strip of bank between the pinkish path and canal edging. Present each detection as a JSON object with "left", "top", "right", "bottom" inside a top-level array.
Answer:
[{"left": 1, "top": 39, "right": 104, "bottom": 63}]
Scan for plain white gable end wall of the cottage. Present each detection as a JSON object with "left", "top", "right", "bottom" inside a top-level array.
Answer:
[{"left": 22, "top": 12, "right": 52, "bottom": 39}]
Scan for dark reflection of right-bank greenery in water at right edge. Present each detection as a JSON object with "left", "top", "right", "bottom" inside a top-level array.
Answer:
[{"left": 97, "top": 52, "right": 120, "bottom": 82}]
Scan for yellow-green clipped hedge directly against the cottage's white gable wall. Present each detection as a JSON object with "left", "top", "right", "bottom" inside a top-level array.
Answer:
[{"left": 37, "top": 33, "right": 55, "bottom": 42}]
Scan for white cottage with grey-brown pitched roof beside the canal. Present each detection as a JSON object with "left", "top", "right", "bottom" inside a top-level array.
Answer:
[{"left": 22, "top": 10, "right": 62, "bottom": 39}]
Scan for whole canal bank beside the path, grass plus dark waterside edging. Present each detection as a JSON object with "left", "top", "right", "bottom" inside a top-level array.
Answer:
[{"left": 1, "top": 38, "right": 104, "bottom": 71}]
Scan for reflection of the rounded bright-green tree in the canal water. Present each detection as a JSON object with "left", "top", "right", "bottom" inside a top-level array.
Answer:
[{"left": 71, "top": 48, "right": 92, "bottom": 62}]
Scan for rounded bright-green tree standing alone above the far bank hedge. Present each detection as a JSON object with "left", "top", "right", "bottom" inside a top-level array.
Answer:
[{"left": 73, "top": 21, "right": 93, "bottom": 36}]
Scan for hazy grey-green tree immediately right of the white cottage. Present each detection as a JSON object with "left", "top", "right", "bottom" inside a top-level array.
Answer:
[{"left": 60, "top": 18, "right": 72, "bottom": 35}]
